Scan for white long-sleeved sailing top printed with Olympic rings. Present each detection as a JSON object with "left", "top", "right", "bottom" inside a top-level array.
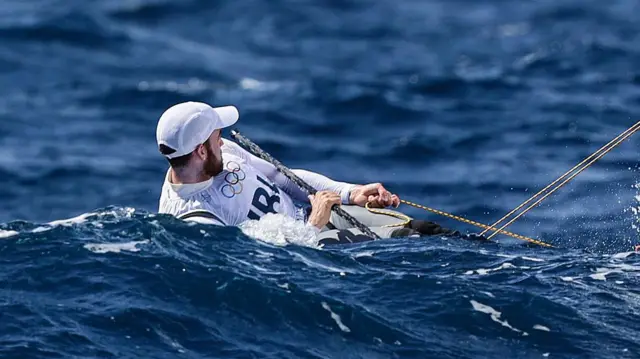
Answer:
[{"left": 158, "top": 139, "right": 355, "bottom": 226}]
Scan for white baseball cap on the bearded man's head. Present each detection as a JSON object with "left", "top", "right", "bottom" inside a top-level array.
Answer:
[{"left": 156, "top": 101, "right": 240, "bottom": 158}]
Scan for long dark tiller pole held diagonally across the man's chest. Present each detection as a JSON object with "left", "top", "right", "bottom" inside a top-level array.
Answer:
[{"left": 231, "top": 130, "right": 381, "bottom": 239}]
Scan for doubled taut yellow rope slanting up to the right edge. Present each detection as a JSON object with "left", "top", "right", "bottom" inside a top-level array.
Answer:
[{"left": 480, "top": 121, "right": 640, "bottom": 239}]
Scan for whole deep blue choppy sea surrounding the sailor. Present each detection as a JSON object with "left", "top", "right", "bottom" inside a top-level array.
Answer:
[{"left": 0, "top": 0, "right": 640, "bottom": 359}]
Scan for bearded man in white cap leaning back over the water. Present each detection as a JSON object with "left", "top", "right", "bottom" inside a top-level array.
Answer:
[{"left": 156, "top": 102, "right": 456, "bottom": 242}]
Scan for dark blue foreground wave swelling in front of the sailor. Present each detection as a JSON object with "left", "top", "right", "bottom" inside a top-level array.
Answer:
[{"left": 0, "top": 207, "right": 640, "bottom": 357}]
